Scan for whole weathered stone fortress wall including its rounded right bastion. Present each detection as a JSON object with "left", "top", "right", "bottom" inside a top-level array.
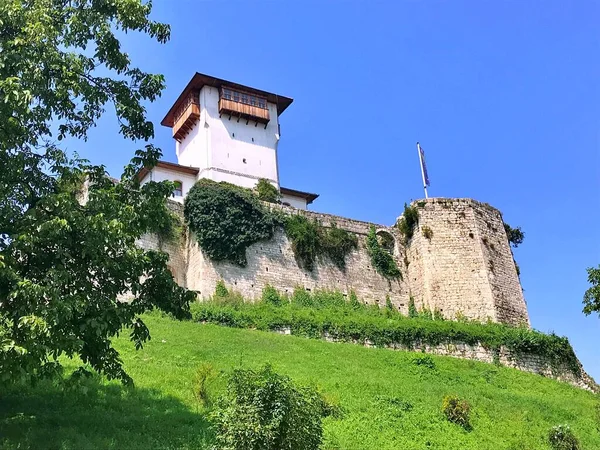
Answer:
[{"left": 140, "top": 198, "right": 529, "bottom": 325}]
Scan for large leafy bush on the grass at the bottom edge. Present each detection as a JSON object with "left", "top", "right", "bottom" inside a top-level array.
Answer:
[{"left": 214, "top": 366, "right": 324, "bottom": 450}]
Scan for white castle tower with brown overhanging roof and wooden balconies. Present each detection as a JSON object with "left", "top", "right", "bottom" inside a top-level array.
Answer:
[{"left": 139, "top": 73, "right": 318, "bottom": 209}]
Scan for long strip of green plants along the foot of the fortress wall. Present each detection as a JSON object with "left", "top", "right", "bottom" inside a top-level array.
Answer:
[{"left": 192, "top": 288, "right": 581, "bottom": 376}]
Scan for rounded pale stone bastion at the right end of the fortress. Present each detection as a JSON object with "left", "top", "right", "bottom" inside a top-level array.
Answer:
[{"left": 407, "top": 198, "right": 529, "bottom": 325}]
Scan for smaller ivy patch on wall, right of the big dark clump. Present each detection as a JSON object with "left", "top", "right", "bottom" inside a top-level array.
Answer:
[{"left": 285, "top": 214, "right": 358, "bottom": 270}]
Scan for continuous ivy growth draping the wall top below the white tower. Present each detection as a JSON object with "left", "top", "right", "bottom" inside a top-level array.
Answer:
[{"left": 184, "top": 179, "right": 358, "bottom": 270}]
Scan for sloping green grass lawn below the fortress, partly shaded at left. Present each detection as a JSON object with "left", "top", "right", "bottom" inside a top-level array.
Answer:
[{"left": 0, "top": 314, "right": 600, "bottom": 450}]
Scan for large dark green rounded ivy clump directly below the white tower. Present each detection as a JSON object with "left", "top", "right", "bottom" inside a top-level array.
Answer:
[{"left": 183, "top": 179, "right": 275, "bottom": 267}]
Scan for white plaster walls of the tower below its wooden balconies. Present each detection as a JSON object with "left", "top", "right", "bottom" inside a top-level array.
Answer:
[{"left": 177, "top": 86, "right": 279, "bottom": 187}]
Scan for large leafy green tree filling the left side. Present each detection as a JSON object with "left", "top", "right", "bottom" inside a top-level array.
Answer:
[{"left": 0, "top": 0, "right": 193, "bottom": 383}]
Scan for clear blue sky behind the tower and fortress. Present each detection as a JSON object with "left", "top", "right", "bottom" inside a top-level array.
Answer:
[{"left": 71, "top": 0, "right": 600, "bottom": 380}]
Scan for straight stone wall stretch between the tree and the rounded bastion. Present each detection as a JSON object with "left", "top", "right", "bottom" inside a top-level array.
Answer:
[{"left": 187, "top": 207, "right": 410, "bottom": 313}]
